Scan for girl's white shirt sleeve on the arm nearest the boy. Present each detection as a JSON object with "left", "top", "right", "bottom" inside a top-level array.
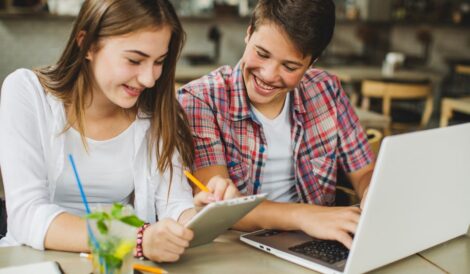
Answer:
[{"left": 155, "top": 153, "right": 194, "bottom": 221}]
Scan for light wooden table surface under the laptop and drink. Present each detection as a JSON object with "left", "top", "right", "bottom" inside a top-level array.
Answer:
[{"left": 0, "top": 231, "right": 470, "bottom": 274}]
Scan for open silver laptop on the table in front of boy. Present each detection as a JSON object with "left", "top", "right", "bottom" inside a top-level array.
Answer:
[{"left": 240, "top": 123, "right": 470, "bottom": 273}]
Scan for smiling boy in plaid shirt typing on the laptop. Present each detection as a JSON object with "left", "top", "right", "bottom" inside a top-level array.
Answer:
[{"left": 179, "top": 0, "right": 374, "bottom": 247}]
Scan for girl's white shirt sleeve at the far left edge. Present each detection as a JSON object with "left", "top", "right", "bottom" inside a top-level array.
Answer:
[{"left": 0, "top": 70, "right": 64, "bottom": 250}]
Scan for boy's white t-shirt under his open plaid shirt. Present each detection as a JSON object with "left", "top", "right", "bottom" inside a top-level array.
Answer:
[{"left": 252, "top": 96, "right": 299, "bottom": 202}]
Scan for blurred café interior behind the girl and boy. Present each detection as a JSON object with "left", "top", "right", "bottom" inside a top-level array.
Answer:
[{"left": 0, "top": 0, "right": 470, "bottom": 135}]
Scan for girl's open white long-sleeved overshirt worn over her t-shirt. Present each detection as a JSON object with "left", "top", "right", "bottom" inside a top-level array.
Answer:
[{"left": 0, "top": 69, "right": 193, "bottom": 250}]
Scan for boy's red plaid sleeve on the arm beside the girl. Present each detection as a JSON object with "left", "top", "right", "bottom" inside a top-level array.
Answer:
[{"left": 178, "top": 84, "right": 226, "bottom": 169}]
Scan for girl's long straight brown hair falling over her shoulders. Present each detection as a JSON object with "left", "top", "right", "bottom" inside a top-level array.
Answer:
[{"left": 35, "top": 0, "right": 194, "bottom": 174}]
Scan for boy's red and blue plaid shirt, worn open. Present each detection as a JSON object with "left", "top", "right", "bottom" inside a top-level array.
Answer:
[{"left": 178, "top": 64, "right": 374, "bottom": 205}]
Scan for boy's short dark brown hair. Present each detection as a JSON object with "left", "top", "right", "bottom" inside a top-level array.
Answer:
[{"left": 250, "top": 0, "right": 335, "bottom": 60}]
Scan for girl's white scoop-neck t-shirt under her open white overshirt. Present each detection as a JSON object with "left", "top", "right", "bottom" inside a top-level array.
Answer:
[{"left": 54, "top": 124, "right": 134, "bottom": 216}]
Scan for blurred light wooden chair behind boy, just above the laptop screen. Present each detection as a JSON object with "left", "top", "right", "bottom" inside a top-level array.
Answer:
[{"left": 361, "top": 79, "right": 433, "bottom": 135}]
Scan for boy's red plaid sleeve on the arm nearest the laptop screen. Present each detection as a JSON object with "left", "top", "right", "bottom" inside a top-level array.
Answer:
[{"left": 335, "top": 78, "right": 374, "bottom": 173}]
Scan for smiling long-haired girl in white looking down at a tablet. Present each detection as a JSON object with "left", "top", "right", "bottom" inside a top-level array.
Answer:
[{"left": 0, "top": 0, "right": 237, "bottom": 261}]
